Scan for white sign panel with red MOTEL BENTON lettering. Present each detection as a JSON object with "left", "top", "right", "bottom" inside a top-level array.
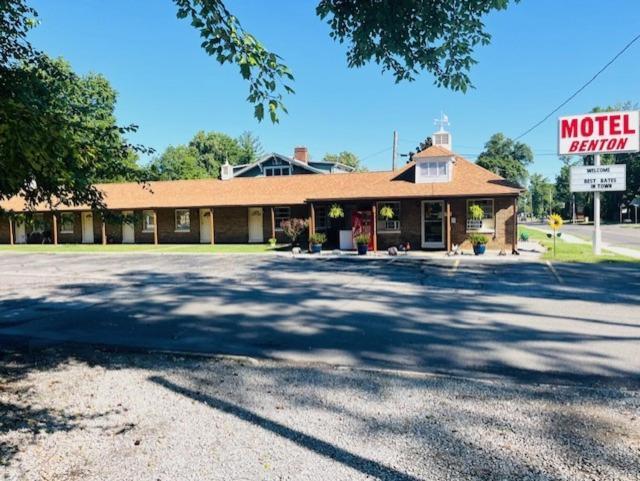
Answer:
[{"left": 558, "top": 110, "right": 640, "bottom": 155}]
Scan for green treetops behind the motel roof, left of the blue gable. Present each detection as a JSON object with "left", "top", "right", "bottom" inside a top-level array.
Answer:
[{"left": 148, "top": 131, "right": 262, "bottom": 180}]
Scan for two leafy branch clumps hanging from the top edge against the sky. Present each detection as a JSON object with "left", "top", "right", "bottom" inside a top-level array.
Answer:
[{"left": 174, "top": 0, "right": 519, "bottom": 123}]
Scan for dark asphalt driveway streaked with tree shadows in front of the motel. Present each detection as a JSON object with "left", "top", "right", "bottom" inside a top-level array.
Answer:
[{"left": 0, "top": 254, "right": 640, "bottom": 383}]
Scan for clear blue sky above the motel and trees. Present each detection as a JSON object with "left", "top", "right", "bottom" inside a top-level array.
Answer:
[{"left": 29, "top": 0, "right": 640, "bottom": 177}]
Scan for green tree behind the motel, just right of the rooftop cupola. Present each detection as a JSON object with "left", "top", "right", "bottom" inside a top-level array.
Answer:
[{"left": 476, "top": 133, "right": 533, "bottom": 185}]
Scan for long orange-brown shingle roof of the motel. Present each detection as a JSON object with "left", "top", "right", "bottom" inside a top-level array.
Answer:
[{"left": 0, "top": 146, "right": 521, "bottom": 210}]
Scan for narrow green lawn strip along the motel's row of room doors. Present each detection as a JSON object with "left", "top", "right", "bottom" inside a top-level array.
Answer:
[{"left": 0, "top": 244, "right": 274, "bottom": 254}]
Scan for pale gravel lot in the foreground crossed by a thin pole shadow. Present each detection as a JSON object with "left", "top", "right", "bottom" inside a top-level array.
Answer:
[{"left": 0, "top": 349, "right": 640, "bottom": 481}]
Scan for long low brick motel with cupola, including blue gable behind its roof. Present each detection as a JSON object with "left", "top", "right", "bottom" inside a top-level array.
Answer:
[{"left": 0, "top": 129, "right": 521, "bottom": 252}]
